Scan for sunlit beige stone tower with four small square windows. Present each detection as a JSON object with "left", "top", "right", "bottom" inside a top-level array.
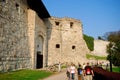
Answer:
[{"left": 46, "top": 17, "right": 89, "bottom": 65}]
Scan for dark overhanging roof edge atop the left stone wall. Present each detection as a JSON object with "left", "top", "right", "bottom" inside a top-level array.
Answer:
[{"left": 27, "top": 0, "right": 50, "bottom": 19}]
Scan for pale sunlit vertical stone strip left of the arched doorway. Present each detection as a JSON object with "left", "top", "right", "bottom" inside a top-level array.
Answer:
[{"left": 28, "top": 9, "right": 36, "bottom": 68}]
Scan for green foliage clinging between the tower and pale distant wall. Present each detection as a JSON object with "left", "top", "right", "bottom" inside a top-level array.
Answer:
[{"left": 83, "top": 34, "right": 94, "bottom": 51}]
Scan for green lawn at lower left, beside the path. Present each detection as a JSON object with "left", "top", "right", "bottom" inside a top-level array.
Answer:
[{"left": 0, "top": 70, "right": 53, "bottom": 80}]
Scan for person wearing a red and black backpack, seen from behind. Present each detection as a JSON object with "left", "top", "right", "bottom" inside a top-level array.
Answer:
[{"left": 84, "top": 63, "right": 94, "bottom": 80}]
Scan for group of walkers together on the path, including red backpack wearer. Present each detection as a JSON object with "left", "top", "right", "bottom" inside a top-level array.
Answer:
[{"left": 66, "top": 63, "right": 94, "bottom": 80}]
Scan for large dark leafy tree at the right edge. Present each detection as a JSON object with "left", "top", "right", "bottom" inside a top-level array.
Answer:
[{"left": 107, "top": 31, "right": 120, "bottom": 67}]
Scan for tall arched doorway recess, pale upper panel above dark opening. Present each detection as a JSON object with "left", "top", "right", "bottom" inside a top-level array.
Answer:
[{"left": 36, "top": 36, "right": 43, "bottom": 69}]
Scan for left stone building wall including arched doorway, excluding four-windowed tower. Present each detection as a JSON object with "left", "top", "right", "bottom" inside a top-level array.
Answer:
[{"left": 0, "top": 0, "right": 47, "bottom": 72}]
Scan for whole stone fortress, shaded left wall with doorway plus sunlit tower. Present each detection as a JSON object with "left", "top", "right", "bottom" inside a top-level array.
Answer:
[{"left": 0, "top": 0, "right": 107, "bottom": 72}]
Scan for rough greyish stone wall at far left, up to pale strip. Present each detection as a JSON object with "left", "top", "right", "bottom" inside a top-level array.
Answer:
[{"left": 0, "top": 0, "right": 31, "bottom": 72}]
